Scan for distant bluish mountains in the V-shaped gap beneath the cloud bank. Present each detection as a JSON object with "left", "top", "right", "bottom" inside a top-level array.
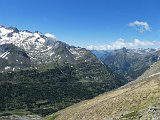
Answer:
[{"left": 92, "top": 48, "right": 160, "bottom": 81}]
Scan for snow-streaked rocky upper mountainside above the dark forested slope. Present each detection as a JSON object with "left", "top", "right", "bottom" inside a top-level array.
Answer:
[{"left": 0, "top": 26, "right": 87, "bottom": 67}]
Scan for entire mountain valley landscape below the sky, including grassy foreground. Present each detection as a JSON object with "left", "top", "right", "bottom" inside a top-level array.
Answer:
[{"left": 0, "top": 26, "right": 160, "bottom": 120}]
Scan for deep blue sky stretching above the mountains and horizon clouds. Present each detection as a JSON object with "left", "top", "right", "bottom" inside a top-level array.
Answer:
[{"left": 0, "top": 0, "right": 160, "bottom": 48}]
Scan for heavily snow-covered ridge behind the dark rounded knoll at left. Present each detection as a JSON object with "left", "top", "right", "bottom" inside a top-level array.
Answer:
[{"left": 0, "top": 25, "right": 56, "bottom": 63}]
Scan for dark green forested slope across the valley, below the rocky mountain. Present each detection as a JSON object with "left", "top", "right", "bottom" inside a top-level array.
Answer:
[{"left": 0, "top": 62, "right": 124, "bottom": 116}]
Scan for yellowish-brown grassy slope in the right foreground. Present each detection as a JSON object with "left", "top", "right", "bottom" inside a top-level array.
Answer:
[{"left": 50, "top": 62, "right": 160, "bottom": 120}]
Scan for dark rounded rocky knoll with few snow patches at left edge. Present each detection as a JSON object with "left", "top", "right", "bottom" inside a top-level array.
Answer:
[{"left": 0, "top": 44, "right": 31, "bottom": 72}]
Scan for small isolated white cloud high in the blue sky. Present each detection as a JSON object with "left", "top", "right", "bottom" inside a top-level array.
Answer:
[{"left": 128, "top": 21, "right": 151, "bottom": 33}]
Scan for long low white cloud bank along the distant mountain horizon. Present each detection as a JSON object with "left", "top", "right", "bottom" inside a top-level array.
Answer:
[{"left": 87, "top": 38, "right": 160, "bottom": 50}]
